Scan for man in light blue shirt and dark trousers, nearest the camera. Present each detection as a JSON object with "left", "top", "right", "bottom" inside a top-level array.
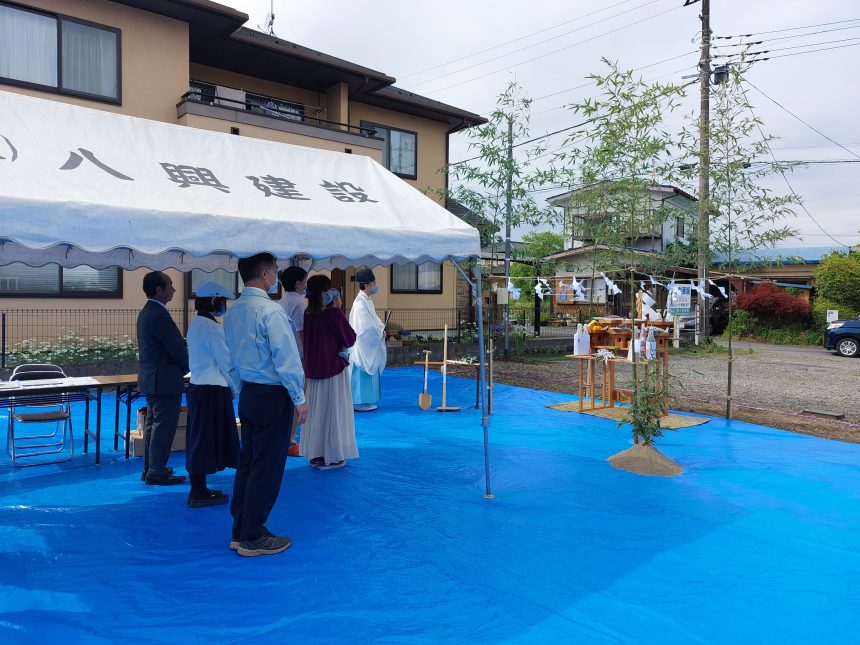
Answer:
[{"left": 224, "top": 253, "right": 308, "bottom": 556}]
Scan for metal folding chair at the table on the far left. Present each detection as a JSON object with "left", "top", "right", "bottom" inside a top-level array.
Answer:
[{"left": 6, "top": 363, "right": 75, "bottom": 466}]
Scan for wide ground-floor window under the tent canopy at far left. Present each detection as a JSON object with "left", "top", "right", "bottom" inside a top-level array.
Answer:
[{"left": 0, "top": 262, "right": 122, "bottom": 298}]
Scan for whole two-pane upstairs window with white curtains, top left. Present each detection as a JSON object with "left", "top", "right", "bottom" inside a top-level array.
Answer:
[{"left": 0, "top": 3, "right": 122, "bottom": 103}]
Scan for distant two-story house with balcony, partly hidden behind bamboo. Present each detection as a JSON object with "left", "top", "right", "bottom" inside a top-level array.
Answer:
[{"left": 546, "top": 184, "right": 698, "bottom": 314}]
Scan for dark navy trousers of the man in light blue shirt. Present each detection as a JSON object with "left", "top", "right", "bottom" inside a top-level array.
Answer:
[{"left": 230, "top": 383, "right": 294, "bottom": 541}]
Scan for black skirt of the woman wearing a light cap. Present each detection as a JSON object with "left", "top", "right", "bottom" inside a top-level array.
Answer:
[{"left": 185, "top": 385, "right": 239, "bottom": 475}]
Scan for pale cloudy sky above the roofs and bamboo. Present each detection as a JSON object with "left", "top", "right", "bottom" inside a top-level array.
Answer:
[{"left": 221, "top": 0, "right": 860, "bottom": 246}]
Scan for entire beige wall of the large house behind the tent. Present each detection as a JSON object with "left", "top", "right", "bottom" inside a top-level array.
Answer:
[{"left": 0, "top": 0, "right": 464, "bottom": 333}]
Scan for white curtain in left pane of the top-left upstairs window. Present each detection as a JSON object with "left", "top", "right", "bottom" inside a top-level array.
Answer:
[{"left": 0, "top": 5, "right": 57, "bottom": 87}]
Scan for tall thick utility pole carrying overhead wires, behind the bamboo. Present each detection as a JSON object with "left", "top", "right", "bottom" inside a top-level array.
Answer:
[{"left": 696, "top": 0, "right": 711, "bottom": 344}]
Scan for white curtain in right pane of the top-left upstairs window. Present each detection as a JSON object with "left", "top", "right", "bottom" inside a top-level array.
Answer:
[{"left": 63, "top": 20, "right": 119, "bottom": 98}]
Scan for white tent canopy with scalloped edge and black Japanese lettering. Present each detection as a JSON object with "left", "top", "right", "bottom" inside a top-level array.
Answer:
[{"left": 0, "top": 91, "right": 480, "bottom": 271}]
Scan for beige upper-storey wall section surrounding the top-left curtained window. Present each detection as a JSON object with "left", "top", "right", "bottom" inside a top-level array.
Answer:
[{"left": 0, "top": 0, "right": 188, "bottom": 123}]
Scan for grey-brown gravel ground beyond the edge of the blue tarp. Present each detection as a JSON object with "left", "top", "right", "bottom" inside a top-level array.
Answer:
[{"left": 484, "top": 343, "right": 860, "bottom": 443}]
